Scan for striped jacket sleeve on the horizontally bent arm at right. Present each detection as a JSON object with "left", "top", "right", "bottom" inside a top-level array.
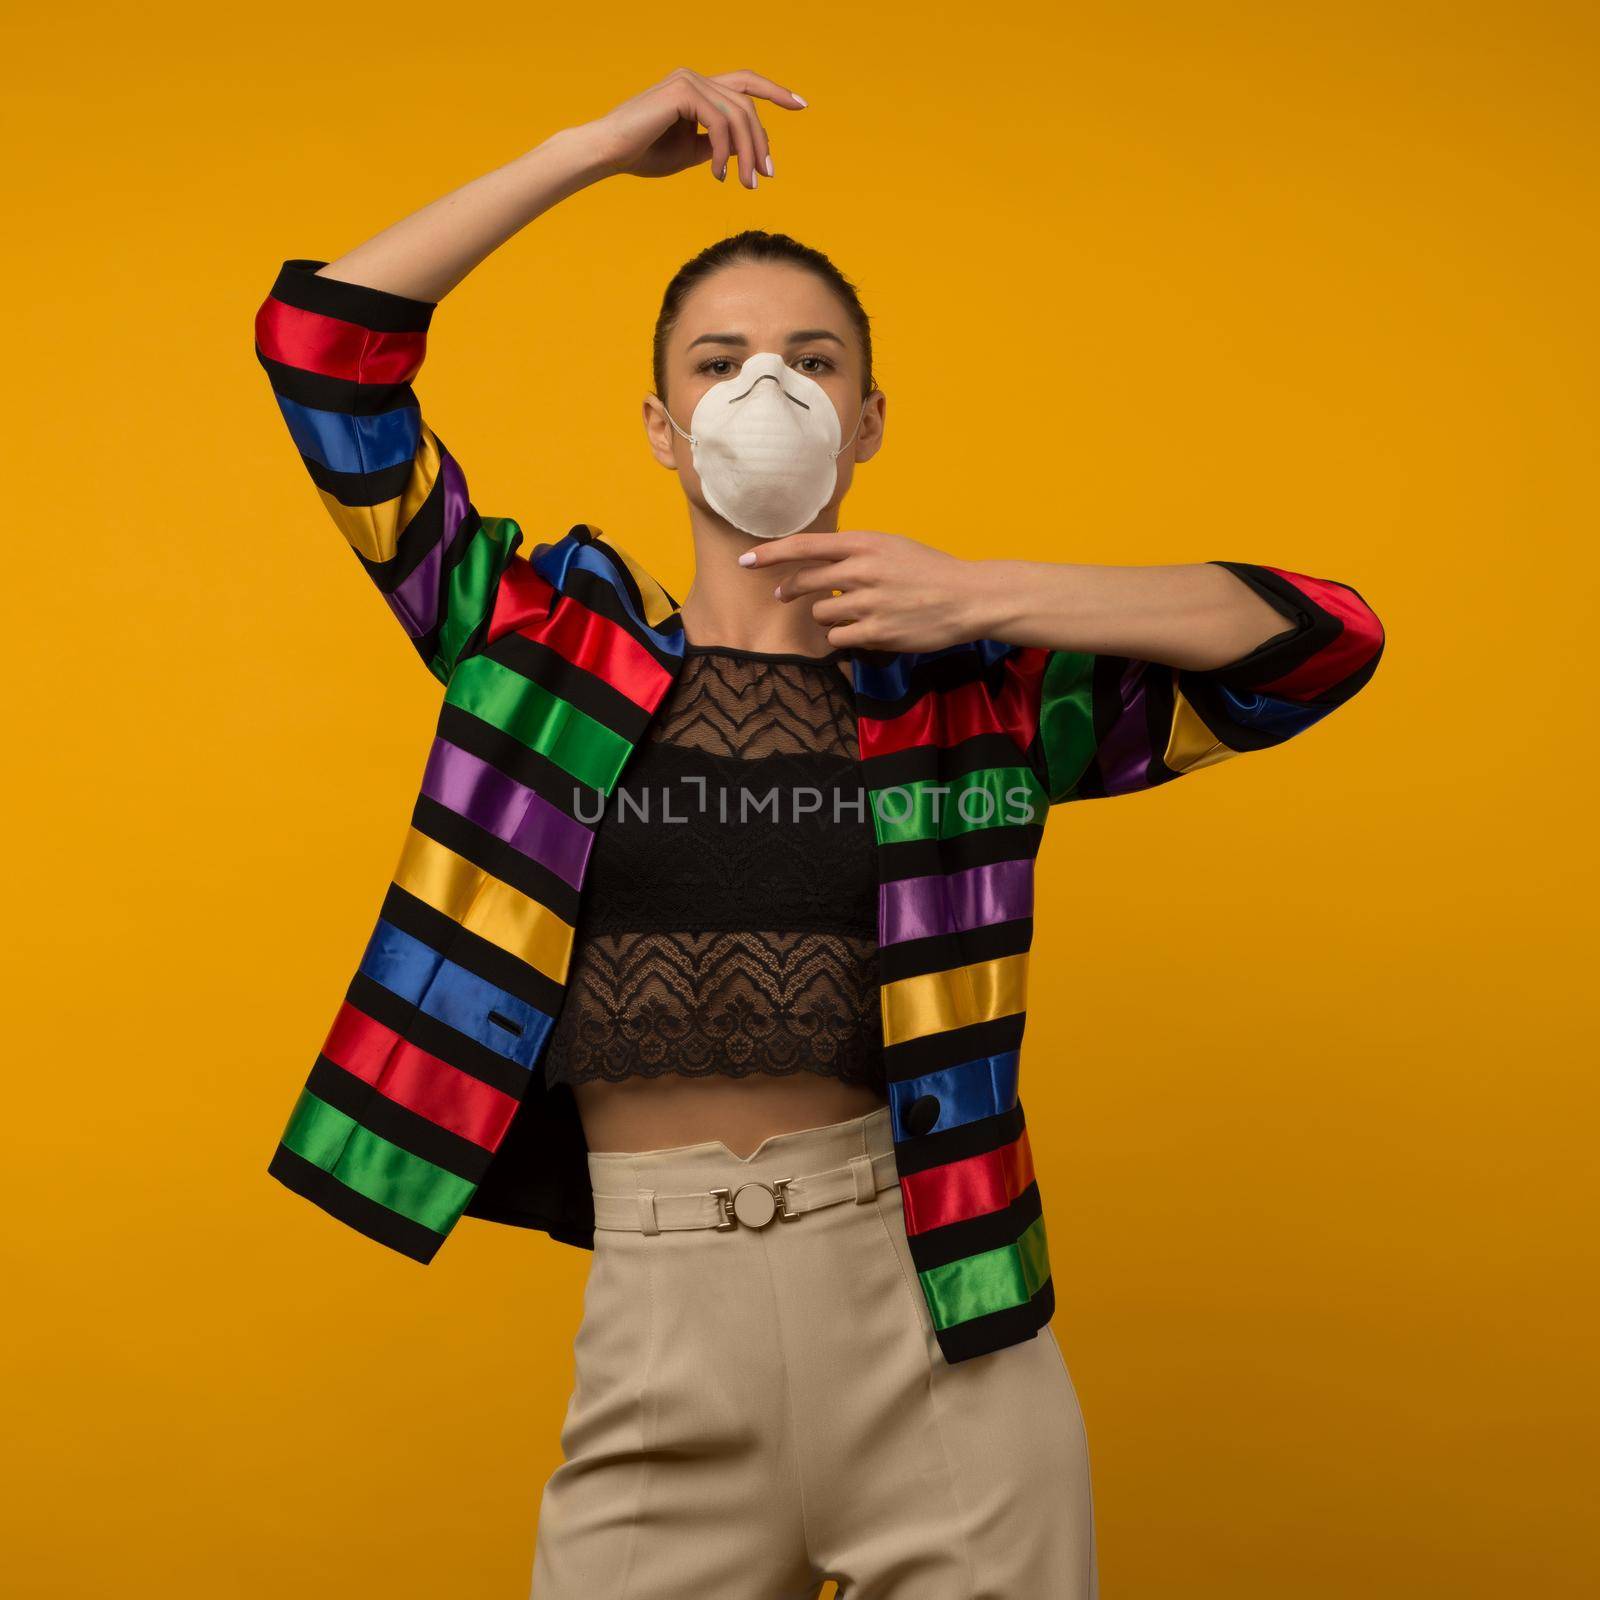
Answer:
[{"left": 1011, "top": 562, "right": 1384, "bottom": 805}]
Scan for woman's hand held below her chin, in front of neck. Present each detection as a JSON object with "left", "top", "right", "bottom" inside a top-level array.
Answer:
[{"left": 739, "top": 531, "right": 982, "bottom": 651}]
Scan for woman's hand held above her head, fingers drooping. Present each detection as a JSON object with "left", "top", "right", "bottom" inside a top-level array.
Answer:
[{"left": 573, "top": 67, "right": 805, "bottom": 189}]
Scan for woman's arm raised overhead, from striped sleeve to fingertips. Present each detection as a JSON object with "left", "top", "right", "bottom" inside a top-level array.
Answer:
[{"left": 256, "top": 70, "right": 805, "bottom": 683}]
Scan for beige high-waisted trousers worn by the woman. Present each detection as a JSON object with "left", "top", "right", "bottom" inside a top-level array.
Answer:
[{"left": 533, "top": 1107, "right": 1098, "bottom": 1600}]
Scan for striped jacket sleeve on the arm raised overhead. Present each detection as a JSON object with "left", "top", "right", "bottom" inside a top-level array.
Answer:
[{"left": 256, "top": 261, "right": 522, "bottom": 683}]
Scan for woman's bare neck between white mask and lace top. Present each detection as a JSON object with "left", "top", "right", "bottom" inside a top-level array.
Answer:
[{"left": 680, "top": 502, "right": 838, "bottom": 656}]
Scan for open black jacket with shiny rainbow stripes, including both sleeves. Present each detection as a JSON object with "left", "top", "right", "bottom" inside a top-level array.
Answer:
[{"left": 256, "top": 261, "right": 1382, "bottom": 1362}]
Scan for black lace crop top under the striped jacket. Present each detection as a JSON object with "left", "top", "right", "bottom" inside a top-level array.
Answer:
[{"left": 544, "top": 645, "right": 883, "bottom": 1090}]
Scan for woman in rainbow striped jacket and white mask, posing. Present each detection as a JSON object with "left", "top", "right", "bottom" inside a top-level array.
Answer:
[{"left": 256, "top": 70, "right": 1382, "bottom": 1600}]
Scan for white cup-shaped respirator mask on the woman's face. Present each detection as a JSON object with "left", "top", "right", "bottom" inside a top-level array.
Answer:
[{"left": 667, "top": 350, "right": 866, "bottom": 539}]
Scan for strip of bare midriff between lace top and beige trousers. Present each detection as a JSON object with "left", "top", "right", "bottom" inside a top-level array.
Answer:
[{"left": 573, "top": 1072, "right": 885, "bottom": 1158}]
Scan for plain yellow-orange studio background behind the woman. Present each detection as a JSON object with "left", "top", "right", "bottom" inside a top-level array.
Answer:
[{"left": 0, "top": 0, "right": 1600, "bottom": 1600}]
